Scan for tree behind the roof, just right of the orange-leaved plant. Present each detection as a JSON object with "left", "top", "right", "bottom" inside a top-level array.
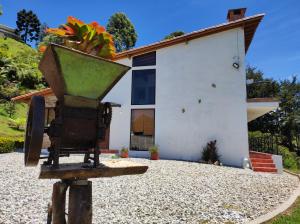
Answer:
[{"left": 106, "top": 12, "right": 137, "bottom": 52}]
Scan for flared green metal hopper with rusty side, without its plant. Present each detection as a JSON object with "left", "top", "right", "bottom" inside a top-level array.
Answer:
[{"left": 39, "top": 44, "right": 130, "bottom": 101}]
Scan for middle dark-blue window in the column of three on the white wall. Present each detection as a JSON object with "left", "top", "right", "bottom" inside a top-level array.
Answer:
[{"left": 131, "top": 69, "right": 155, "bottom": 105}]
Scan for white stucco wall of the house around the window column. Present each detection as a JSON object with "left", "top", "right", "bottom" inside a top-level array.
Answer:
[{"left": 105, "top": 28, "right": 248, "bottom": 166}]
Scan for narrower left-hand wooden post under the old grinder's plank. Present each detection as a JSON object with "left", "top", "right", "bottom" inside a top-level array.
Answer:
[{"left": 52, "top": 181, "right": 68, "bottom": 224}]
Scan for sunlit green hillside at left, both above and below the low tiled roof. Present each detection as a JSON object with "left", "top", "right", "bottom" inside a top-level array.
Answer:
[{"left": 0, "top": 38, "right": 40, "bottom": 137}]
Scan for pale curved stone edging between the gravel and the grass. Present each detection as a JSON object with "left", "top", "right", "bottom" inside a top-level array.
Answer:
[{"left": 248, "top": 170, "right": 300, "bottom": 224}]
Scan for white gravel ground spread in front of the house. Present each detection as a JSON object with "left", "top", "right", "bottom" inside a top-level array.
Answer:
[{"left": 0, "top": 153, "right": 299, "bottom": 224}]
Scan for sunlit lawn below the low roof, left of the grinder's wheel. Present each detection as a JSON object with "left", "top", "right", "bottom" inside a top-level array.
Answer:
[{"left": 0, "top": 104, "right": 27, "bottom": 137}]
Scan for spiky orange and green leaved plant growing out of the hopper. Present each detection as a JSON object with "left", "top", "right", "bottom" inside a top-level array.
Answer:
[{"left": 39, "top": 16, "right": 115, "bottom": 59}]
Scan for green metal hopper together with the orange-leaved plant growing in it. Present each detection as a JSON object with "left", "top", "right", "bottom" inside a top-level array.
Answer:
[{"left": 39, "top": 16, "right": 130, "bottom": 102}]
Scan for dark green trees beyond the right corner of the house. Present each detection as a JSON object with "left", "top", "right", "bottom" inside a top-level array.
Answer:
[{"left": 247, "top": 67, "right": 300, "bottom": 151}]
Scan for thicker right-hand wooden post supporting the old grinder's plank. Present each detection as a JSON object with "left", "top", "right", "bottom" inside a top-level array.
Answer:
[{"left": 68, "top": 180, "right": 92, "bottom": 224}]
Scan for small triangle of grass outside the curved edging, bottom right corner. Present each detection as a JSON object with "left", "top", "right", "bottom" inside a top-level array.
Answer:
[{"left": 264, "top": 197, "right": 300, "bottom": 224}]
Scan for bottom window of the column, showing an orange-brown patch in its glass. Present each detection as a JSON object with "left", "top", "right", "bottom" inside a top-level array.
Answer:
[{"left": 130, "top": 109, "right": 155, "bottom": 151}]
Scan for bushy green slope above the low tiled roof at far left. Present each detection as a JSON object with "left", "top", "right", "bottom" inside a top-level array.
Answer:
[{"left": 0, "top": 38, "right": 44, "bottom": 100}]
